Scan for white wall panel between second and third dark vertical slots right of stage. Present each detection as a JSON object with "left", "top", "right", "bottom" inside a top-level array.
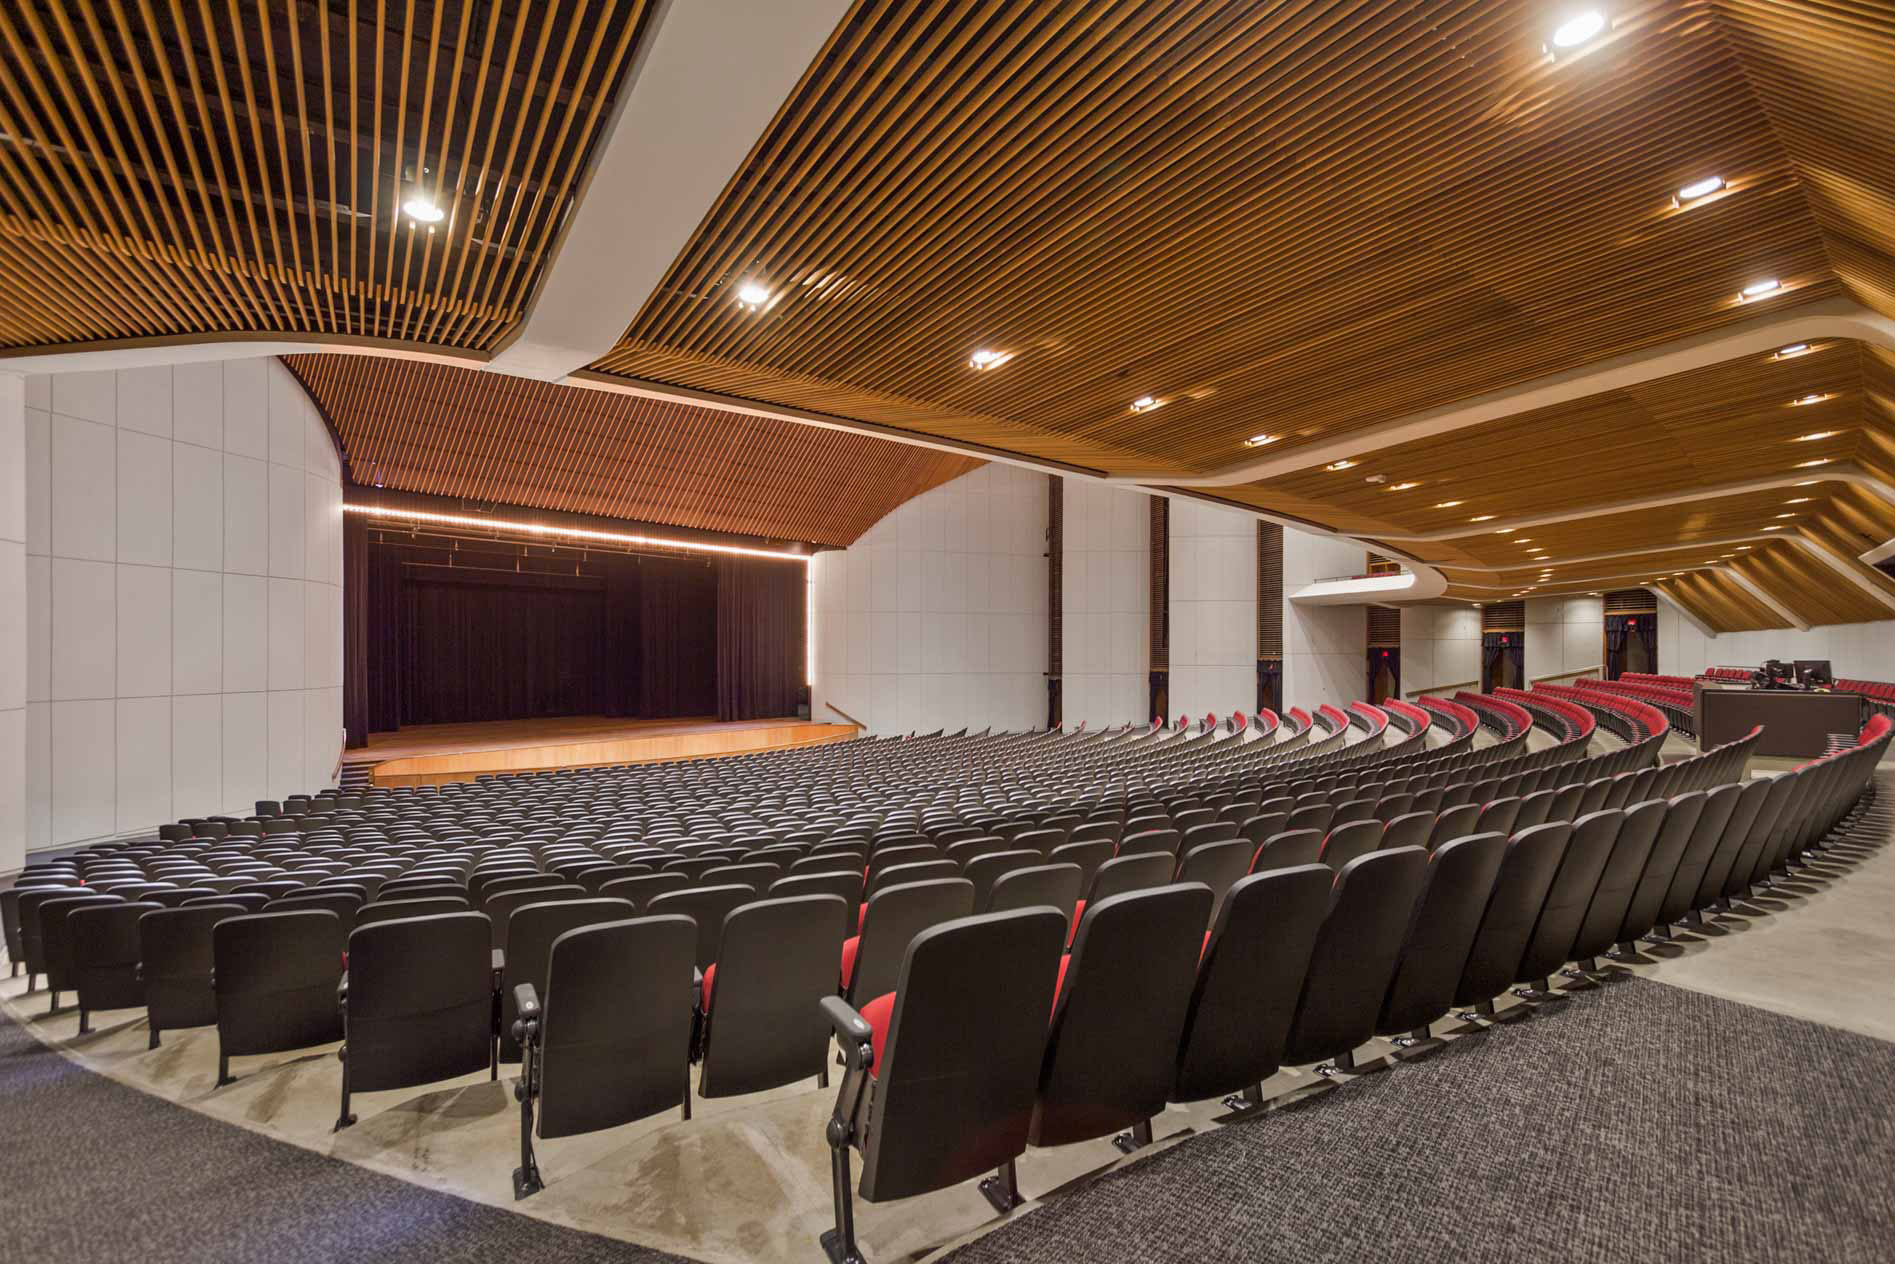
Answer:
[{"left": 1169, "top": 498, "right": 1258, "bottom": 720}]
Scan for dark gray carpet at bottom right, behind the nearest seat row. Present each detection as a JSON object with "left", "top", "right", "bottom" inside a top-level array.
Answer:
[{"left": 951, "top": 976, "right": 1895, "bottom": 1264}]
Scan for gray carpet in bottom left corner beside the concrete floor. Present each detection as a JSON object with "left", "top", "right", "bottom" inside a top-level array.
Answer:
[{"left": 0, "top": 1014, "right": 697, "bottom": 1264}]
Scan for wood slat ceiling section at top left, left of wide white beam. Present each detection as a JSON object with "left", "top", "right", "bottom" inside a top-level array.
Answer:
[{"left": 0, "top": 0, "right": 646, "bottom": 349}]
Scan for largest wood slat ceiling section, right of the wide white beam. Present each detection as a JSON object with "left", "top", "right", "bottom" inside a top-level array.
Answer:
[{"left": 597, "top": 0, "right": 1872, "bottom": 470}]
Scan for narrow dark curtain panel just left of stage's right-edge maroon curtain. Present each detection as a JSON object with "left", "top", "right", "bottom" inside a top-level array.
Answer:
[{"left": 639, "top": 557, "right": 718, "bottom": 718}]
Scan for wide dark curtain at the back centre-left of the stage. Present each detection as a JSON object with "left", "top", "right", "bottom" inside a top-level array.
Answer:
[{"left": 402, "top": 569, "right": 605, "bottom": 724}]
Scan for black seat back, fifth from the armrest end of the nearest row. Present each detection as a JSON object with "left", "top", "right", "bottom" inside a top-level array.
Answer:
[{"left": 1376, "top": 834, "right": 1507, "bottom": 1037}]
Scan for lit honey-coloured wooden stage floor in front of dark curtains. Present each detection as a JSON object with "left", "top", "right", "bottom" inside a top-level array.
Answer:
[{"left": 343, "top": 716, "right": 857, "bottom": 786}]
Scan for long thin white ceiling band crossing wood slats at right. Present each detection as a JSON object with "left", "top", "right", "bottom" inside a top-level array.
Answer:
[{"left": 1112, "top": 299, "right": 1895, "bottom": 487}]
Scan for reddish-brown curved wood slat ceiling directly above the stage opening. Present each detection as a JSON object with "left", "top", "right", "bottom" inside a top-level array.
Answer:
[{"left": 284, "top": 354, "right": 982, "bottom": 546}]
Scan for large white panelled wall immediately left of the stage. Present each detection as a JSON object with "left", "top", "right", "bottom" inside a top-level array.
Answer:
[{"left": 25, "top": 358, "right": 343, "bottom": 849}]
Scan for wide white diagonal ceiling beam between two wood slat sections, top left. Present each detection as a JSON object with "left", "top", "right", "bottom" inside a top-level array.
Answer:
[{"left": 489, "top": 0, "right": 849, "bottom": 381}]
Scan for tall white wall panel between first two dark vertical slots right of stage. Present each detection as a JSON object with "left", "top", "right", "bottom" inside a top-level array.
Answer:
[{"left": 1059, "top": 478, "right": 1152, "bottom": 728}]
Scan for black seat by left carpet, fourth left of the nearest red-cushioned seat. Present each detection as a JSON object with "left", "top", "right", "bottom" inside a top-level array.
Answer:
[{"left": 215, "top": 906, "right": 348, "bottom": 1088}]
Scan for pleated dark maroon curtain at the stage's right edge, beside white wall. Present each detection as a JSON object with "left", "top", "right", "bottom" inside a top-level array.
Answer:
[{"left": 716, "top": 557, "right": 809, "bottom": 720}]
